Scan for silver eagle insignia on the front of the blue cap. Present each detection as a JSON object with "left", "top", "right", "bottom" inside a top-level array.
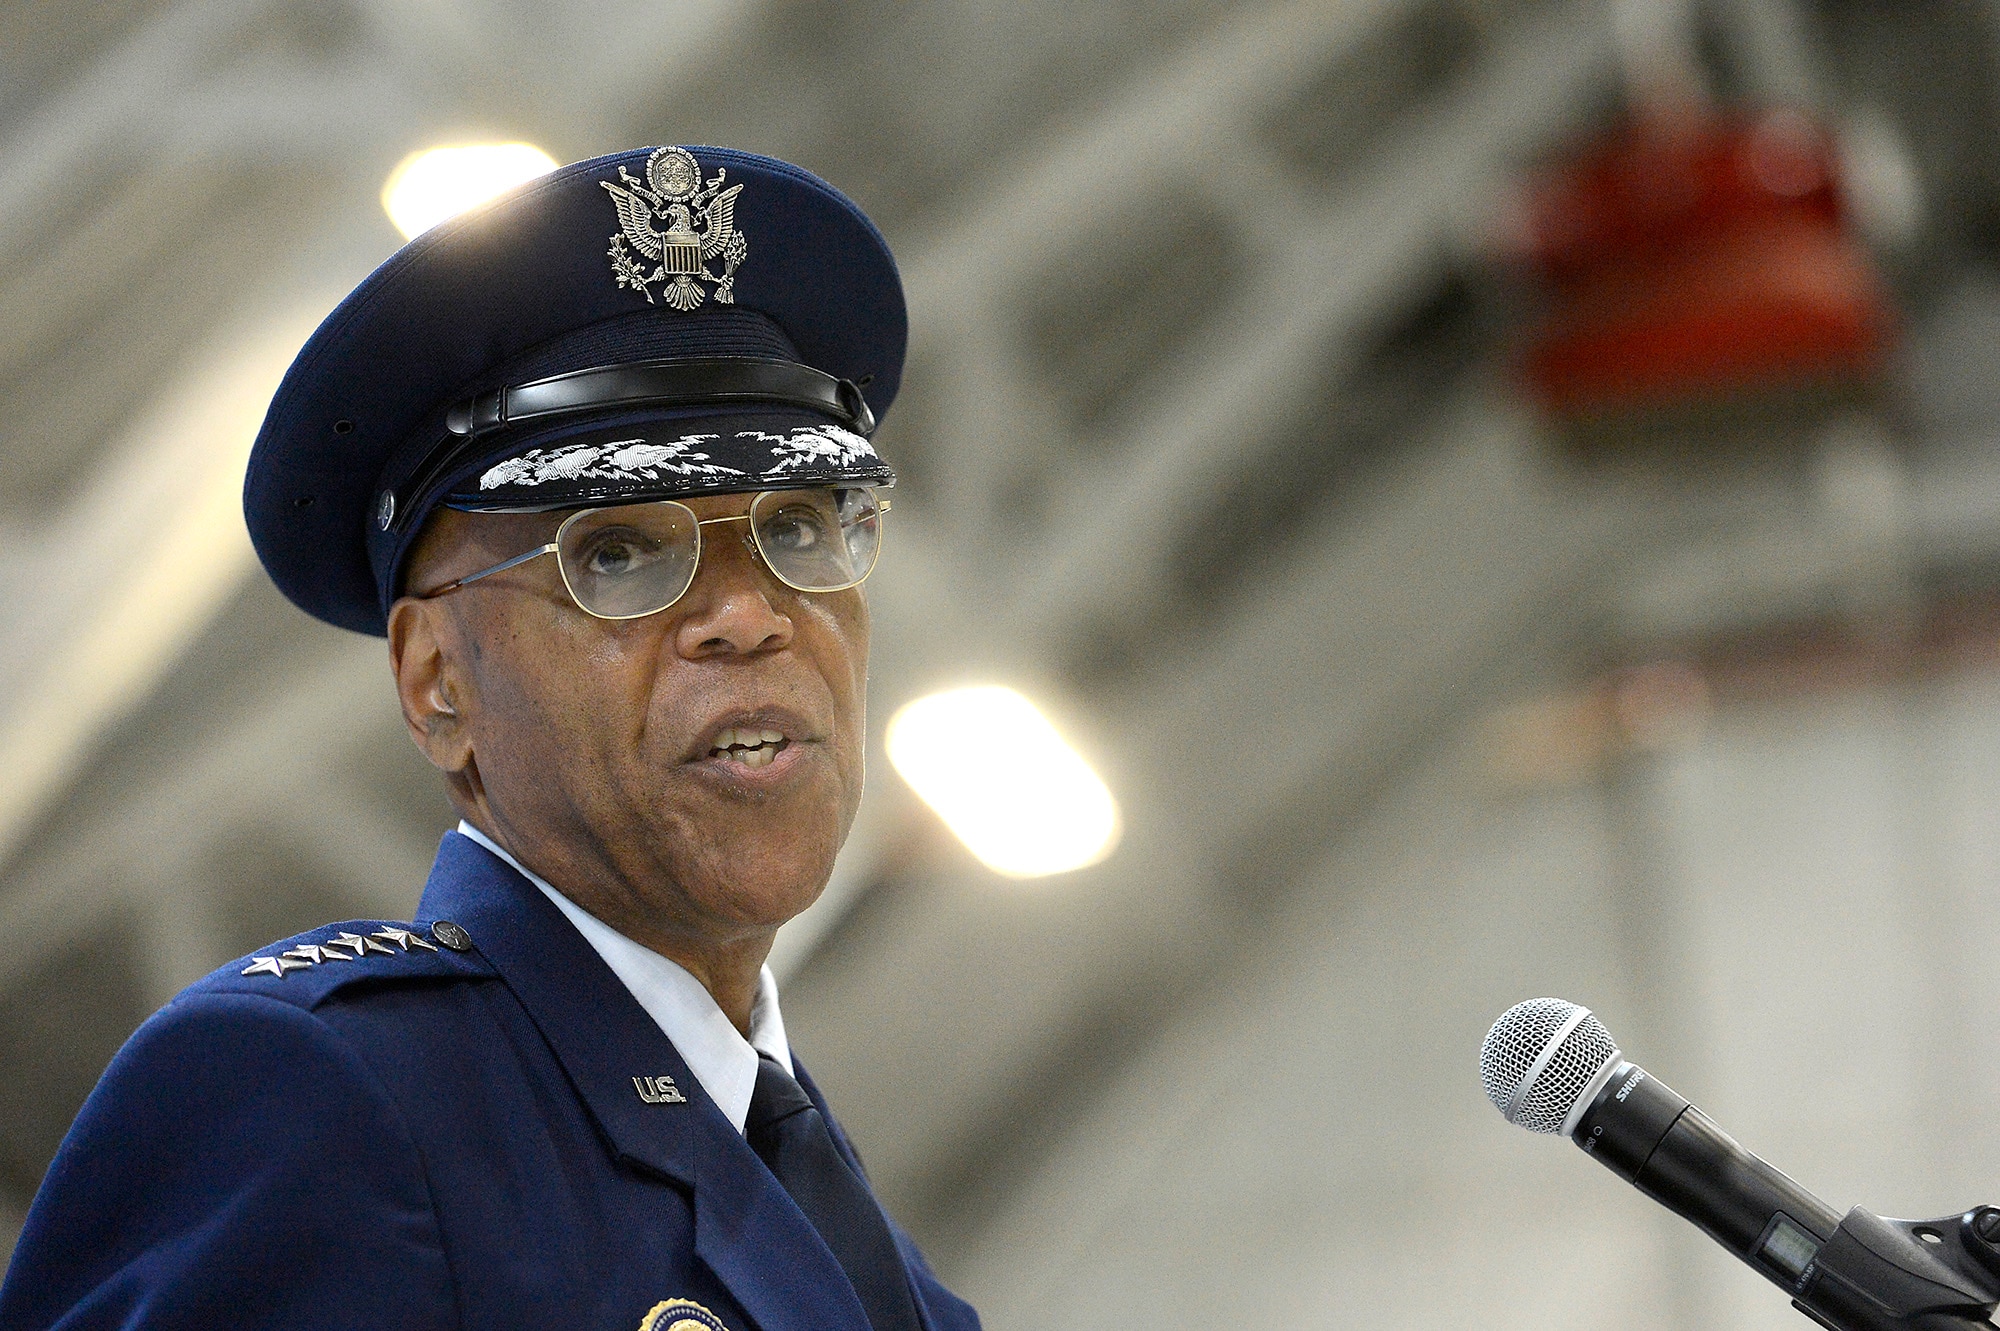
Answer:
[{"left": 598, "top": 148, "right": 750, "bottom": 314}]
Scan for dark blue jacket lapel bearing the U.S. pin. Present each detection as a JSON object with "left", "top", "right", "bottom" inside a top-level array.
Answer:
[{"left": 418, "top": 831, "right": 868, "bottom": 1331}]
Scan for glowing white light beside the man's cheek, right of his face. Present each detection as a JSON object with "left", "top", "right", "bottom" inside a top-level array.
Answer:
[{"left": 888, "top": 687, "right": 1118, "bottom": 877}]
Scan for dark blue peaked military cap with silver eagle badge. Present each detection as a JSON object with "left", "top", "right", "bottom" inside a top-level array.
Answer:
[{"left": 244, "top": 148, "right": 908, "bottom": 634}]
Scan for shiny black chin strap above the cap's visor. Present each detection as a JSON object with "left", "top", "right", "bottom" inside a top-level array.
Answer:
[{"left": 374, "top": 356, "right": 876, "bottom": 534}]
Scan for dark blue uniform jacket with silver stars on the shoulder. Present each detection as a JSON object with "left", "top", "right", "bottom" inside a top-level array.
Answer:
[{"left": 0, "top": 833, "right": 978, "bottom": 1331}]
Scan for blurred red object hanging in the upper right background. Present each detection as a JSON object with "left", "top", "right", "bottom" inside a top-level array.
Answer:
[{"left": 1516, "top": 110, "right": 1894, "bottom": 418}]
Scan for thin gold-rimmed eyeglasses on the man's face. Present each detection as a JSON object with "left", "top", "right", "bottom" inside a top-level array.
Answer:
[{"left": 412, "top": 486, "right": 888, "bottom": 620}]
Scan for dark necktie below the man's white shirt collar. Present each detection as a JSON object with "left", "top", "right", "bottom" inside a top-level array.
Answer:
[{"left": 744, "top": 1055, "right": 924, "bottom": 1331}]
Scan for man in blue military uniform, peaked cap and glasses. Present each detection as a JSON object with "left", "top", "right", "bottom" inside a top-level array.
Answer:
[{"left": 0, "top": 148, "right": 978, "bottom": 1331}]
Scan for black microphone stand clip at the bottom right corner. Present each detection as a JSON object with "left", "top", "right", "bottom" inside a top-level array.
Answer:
[{"left": 1792, "top": 1207, "right": 2000, "bottom": 1331}]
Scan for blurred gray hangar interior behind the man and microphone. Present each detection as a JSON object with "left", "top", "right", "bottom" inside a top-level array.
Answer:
[{"left": 11, "top": 0, "right": 2000, "bottom": 1331}]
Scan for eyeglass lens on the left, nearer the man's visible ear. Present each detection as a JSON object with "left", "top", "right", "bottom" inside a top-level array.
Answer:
[{"left": 556, "top": 500, "right": 698, "bottom": 620}]
